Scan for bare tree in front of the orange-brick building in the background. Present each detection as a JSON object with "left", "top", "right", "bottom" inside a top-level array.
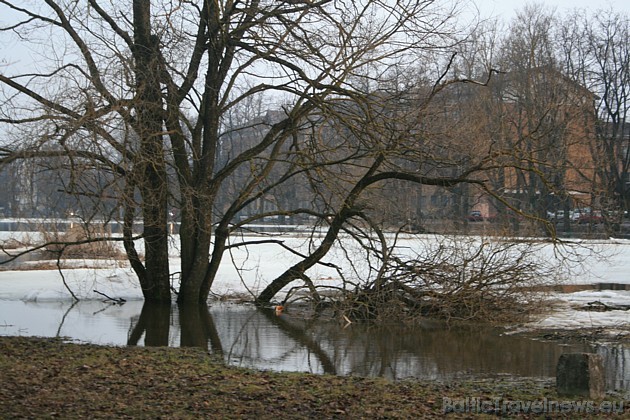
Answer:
[{"left": 484, "top": 5, "right": 595, "bottom": 233}]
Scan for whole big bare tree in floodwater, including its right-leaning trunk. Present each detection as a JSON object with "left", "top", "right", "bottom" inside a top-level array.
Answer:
[{"left": 0, "top": 0, "right": 568, "bottom": 303}]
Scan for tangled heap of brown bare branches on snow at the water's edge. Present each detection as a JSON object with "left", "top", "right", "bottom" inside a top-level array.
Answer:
[{"left": 336, "top": 237, "right": 559, "bottom": 323}]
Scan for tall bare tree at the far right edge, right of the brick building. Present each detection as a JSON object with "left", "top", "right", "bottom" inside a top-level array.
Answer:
[{"left": 560, "top": 10, "right": 630, "bottom": 223}]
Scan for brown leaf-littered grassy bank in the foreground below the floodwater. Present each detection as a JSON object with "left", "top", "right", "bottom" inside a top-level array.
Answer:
[{"left": 0, "top": 337, "right": 630, "bottom": 419}]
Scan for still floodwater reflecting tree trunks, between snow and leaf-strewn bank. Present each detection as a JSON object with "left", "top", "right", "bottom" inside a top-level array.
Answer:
[{"left": 0, "top": 301, "right": 630, "bottom": 390}]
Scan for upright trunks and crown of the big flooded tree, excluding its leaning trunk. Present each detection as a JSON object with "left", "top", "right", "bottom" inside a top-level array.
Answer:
[{"left": 0, "top": 0, "right": 470, "bottom": 302}]
